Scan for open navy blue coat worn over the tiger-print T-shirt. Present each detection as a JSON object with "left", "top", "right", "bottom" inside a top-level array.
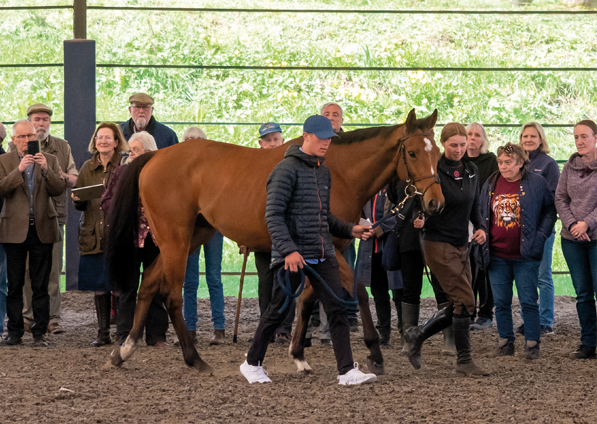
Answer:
[{"left": 479, "top": 167, "right": 557, "bottom": 266}]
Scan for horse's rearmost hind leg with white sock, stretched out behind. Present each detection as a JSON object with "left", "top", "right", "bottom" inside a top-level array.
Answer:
[{"left": 110, "top": 256, "right": 164, "bottom": 367}]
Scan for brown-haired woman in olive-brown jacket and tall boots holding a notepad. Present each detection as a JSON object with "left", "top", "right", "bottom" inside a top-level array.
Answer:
[{"left": 71, "top": 122, "right": 128, "bottom": 346}]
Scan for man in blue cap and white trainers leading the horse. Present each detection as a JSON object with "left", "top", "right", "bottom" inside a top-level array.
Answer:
[{"left": 240, "top": 115, "right": 377, "bottom": 385}]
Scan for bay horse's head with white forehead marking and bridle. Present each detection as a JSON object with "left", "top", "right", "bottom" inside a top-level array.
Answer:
[{"left": 398, "top": 109, "right": 445, "bottom": 215}]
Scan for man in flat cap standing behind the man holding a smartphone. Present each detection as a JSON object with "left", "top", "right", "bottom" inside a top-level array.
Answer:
[{"left": 17, "top": 103, "right": 79, "bottom": 334}]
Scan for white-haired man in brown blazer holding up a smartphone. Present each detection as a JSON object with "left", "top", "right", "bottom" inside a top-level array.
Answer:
[{"left": 0, "top": 119, "right": 65, "bottom": 346}]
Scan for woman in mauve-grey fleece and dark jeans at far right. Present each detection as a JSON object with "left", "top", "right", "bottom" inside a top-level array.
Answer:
[{"left": 556, "top": 120, "right": 597, "bottom": 359}]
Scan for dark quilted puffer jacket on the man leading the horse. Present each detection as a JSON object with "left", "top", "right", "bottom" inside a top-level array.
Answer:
[{"left": 265, "top": 144, "right": 353, "bottom": 267}]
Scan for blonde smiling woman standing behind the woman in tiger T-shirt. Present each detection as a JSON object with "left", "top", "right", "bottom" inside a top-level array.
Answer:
[{"left": 516, "top": 122, "right": 560, "bottom": 335}]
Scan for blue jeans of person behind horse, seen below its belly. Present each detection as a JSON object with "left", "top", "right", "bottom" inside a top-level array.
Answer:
[{"left": 183, "top": 232, "right": 225, "bottom": 331}]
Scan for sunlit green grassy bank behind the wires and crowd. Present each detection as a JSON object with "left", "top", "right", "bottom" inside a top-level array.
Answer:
[{"left": 7, "top": 0, "right": 597, "bottom": 296}]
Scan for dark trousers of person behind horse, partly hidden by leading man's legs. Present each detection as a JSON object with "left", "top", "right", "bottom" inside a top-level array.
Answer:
[{"left": 255, "top": 252, "right": 296, "bottom": 336}]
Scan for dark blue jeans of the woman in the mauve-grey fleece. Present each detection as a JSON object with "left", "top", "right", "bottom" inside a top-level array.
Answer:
[{"left": 560, "top": 238, "right": 597, "bottom": 347}]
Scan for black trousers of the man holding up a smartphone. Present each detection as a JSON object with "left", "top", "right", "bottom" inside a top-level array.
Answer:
[{"left": 3, "top": 225, "right": 54, "bottom": 337}]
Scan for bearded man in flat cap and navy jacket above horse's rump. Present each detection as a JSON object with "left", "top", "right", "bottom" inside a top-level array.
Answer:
[{"left": 120, "top": 93, "right": 178, "bottom": 149}]
